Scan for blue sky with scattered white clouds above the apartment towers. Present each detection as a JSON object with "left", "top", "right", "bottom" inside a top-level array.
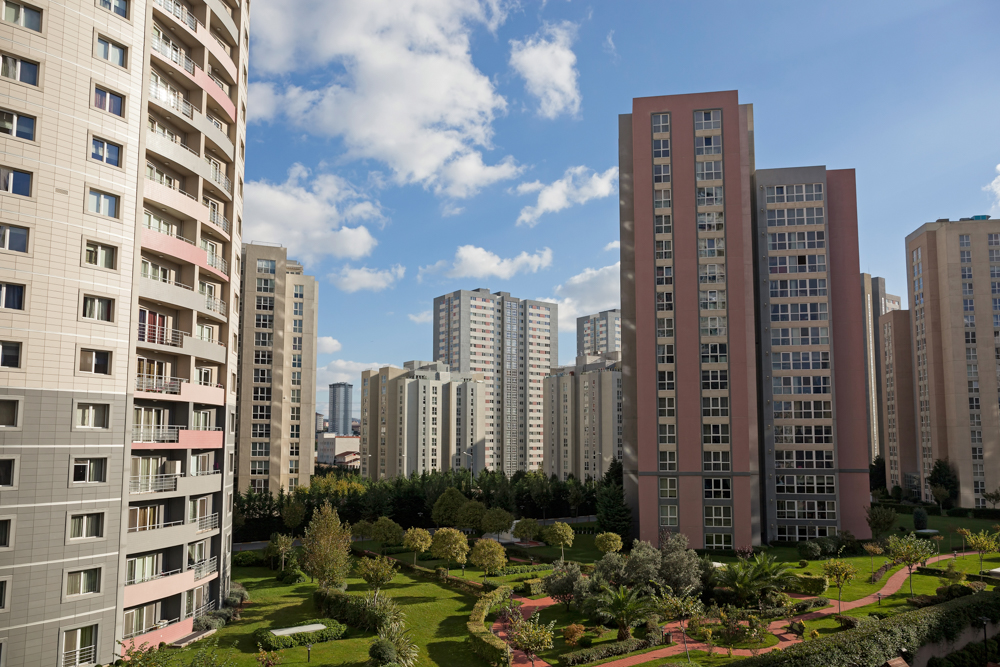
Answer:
[{"left": 243, "top": 0, "right": 1000, "bottom": 415}]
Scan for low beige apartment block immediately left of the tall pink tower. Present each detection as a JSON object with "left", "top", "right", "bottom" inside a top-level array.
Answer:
[{"left": 543, "top": 352, "right": 622, "bottom": 480}]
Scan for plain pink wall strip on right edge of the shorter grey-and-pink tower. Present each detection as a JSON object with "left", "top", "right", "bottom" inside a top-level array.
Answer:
[{"left": 826, "top": 169, "right": 871, "bottom": 539}]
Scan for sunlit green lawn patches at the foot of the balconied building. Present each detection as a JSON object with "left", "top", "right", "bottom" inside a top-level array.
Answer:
[{"left": 186, "top": 567, "right": 482, "bottom": 667}]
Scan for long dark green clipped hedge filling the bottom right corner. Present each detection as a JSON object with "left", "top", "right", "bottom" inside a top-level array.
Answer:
[{"left": 740, "top": 593, "right": 1000, "bottom": 667}]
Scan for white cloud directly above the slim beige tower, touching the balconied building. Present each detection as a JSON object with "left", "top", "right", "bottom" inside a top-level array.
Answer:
[{"left": 243, "top": 163, "right": 382, "bottom": 264}]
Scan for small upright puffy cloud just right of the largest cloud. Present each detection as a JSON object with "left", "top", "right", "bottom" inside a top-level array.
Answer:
[{"left": 510, "top": 21, "right": 582, "bottom": 118}]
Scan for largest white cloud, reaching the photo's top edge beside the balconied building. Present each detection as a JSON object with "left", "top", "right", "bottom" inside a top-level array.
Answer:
[{"left": 250, "top": 0, "right": 521, "bottom": 198}]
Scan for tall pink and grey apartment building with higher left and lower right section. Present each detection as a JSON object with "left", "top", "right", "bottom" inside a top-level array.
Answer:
[{"left": 619, "top": 91, "right": 867, "bottom": 549}]
